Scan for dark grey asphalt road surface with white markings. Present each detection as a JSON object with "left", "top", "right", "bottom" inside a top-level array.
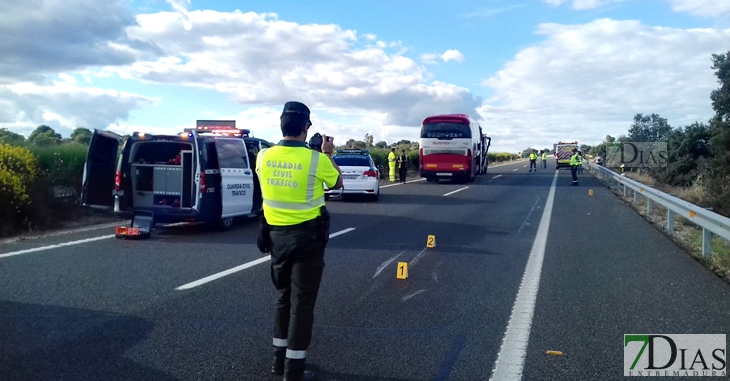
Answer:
[{"left": 0, "top": 162, "right": 730, "bottom": 381}]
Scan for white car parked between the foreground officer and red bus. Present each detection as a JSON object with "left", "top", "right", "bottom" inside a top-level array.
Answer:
[{"left": 324, "top": 149, "right": 380, "bottom": 201}]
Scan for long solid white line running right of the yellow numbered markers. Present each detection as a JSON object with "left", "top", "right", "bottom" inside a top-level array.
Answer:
[{"left": 490, "top": 172, "right": 558, "bottom": 381}]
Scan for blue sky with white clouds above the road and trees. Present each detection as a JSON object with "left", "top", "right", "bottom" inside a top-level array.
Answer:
[{"left": 0, "top": 0, "right": 730, "bottom": 152}]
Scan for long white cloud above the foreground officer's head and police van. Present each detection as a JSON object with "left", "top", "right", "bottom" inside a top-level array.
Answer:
[{"left": 107, "top": 11, "right": 481, "bottom": 126}]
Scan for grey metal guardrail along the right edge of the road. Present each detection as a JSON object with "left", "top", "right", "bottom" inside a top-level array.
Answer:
[{"left": 584, "top": 161, "right": 730, "bottom": 258}]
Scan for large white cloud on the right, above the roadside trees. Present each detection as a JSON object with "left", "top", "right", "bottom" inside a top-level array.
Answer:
[{"left": 479, "top": 19, "right": 730, "bottom": 149}]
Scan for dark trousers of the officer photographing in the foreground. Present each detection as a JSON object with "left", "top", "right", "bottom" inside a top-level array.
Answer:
[{"left": 271, "top": 225, "right": 325, "bottom": 380}]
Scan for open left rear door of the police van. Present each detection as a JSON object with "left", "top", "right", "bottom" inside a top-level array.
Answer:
[{"left": 81, "top": 130, "right": 122, "bottom": 208}]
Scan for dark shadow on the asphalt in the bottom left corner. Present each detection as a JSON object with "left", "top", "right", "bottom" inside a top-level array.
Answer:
[{"left": 0, "top": 301, "right": 176, "bottom": 381}]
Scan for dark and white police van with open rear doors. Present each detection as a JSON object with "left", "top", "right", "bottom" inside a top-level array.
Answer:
[{"left": 81, "top": 120, "right": 273, "bottom": 233}]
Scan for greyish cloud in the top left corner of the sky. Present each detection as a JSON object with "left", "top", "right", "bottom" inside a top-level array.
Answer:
[{"left": 0, "top": 0, "right": 159, "bottom": 84}]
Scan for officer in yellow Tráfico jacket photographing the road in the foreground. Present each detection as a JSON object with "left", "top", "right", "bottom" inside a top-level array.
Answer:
[{"left": 256, "top": 102, "right": 342, "bottom": 381}]
